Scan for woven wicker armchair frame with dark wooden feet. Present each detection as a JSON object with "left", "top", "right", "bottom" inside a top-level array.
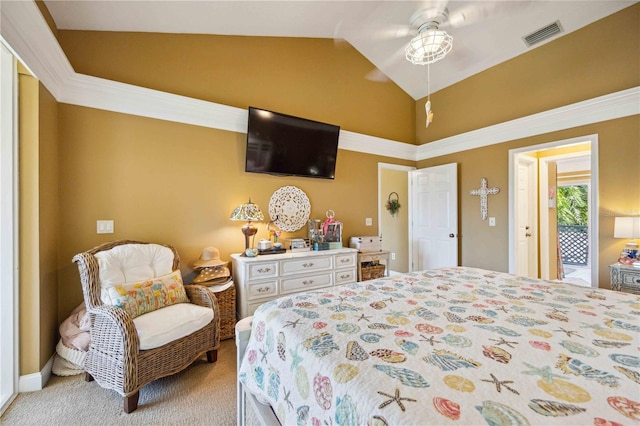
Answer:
[{"left": 73, "top": 240, "right": 220, "bottom": 413}]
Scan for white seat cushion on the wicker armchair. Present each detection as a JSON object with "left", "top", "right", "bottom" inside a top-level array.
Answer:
[{"left": 133, "top": 303, "right": 213, "bottom": 350}]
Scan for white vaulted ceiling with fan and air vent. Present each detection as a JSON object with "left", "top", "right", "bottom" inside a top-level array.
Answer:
[{"left": 45, "top": 0, "right": 636, "bottom": 99}]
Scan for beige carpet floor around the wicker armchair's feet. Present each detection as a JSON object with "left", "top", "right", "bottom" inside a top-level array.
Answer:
[{"left": 0, "top": 339, "right": 252, "bottom": 426}]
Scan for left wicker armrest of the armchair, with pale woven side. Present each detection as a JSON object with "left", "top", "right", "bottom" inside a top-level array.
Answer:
[{"left": 87, "top": 305, "right": 140, "bottom": 363}]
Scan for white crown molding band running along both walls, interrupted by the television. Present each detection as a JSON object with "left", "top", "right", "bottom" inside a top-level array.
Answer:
[{"left": 0, "top": 1, "right": 640, "bottom": 161}]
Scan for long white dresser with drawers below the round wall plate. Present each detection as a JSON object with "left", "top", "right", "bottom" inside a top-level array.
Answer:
[{"left": 231, "top": 248, "right": 358, "bottom": 318}]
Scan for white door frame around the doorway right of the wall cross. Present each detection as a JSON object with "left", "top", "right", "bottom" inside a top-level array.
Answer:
[{"left": 509, "top": 134, "right": 599, "bottom": 286}]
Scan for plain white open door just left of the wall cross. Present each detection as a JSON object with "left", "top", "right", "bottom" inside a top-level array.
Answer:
[{"left": 409, "top": 163, "right": 458, "bottom": 271}]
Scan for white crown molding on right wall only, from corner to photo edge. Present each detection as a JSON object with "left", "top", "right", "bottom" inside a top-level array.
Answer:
[{"left": 417, "top": 87, "right": 640, "bottom": 160}]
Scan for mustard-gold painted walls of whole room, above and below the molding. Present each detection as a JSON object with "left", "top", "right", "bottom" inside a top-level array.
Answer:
[{"left": 20, "top": 4, "right": 640, "bottom": 374}]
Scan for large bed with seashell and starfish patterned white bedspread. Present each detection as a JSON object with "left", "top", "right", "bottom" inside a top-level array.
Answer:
[{"left": 236, "top": 267, "right": 640, "bottom": 425}]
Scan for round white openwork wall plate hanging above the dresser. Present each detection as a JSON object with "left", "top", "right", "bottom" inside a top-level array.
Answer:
[{"left": 269, "top": 186, "right": 311, "bottom": 232}]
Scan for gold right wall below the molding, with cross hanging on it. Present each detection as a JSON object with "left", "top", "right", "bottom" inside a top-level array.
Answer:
[{"left": 418, "top": 115, "right": 640, "bottom": 288}]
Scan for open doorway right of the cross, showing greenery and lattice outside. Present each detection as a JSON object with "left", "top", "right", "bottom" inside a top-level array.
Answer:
[{"left": 509, "top": 135, "right": 598, "bottom": 286}]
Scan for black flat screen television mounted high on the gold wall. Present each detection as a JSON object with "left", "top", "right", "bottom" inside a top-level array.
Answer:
[{"left": 245, "top": 107, "right": 340, "bottom": 179}]
